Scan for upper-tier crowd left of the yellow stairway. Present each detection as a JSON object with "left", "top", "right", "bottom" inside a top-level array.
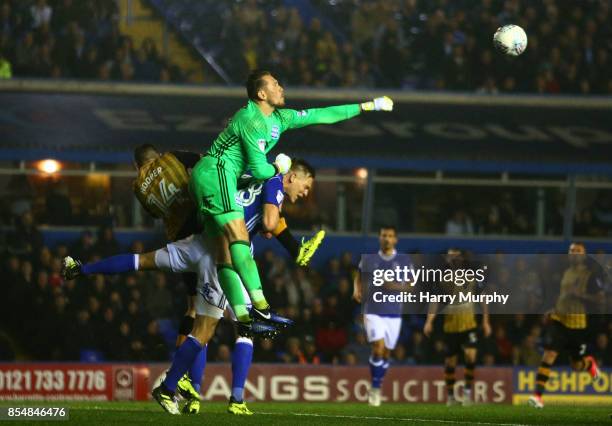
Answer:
[{"left": 0, "top": 0, "right": 185, "bottom": 82}]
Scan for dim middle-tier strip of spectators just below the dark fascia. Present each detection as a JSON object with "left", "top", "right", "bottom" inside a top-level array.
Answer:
[{"left": 0, "top": 175, "right": 612, "bottom": 241}]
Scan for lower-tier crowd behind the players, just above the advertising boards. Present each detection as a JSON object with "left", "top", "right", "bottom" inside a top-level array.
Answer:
[{"left": 0, "top": 211, "right": 612, "bottom": 366}]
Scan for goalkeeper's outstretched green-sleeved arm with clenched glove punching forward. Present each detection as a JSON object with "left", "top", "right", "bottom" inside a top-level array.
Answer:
[{"left": 279, "top": 96, "right": 393, "bottom": 130}]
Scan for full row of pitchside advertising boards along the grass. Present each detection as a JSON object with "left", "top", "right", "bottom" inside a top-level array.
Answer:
[{"left": 0, "top": 363, "right": 612, "bottom": 404}]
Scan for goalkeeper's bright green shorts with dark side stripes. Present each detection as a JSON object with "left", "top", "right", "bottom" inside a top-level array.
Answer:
[{"left": 189, "top": 156, "right": 244, "bottom": 235}]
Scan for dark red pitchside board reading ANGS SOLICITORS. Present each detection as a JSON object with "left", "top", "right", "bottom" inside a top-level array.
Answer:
[{"left": 150, "top": 364, "right": 513, "bottom": 404}]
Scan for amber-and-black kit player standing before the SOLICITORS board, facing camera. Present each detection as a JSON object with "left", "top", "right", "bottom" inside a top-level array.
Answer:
[{"left": 423, "top": 249, "right": 491, "bottom": 406}]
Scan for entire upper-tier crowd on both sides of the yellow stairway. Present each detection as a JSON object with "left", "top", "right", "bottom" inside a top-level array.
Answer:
[{"left": 0, "top": 0, "right": 612, "bottom": 94}]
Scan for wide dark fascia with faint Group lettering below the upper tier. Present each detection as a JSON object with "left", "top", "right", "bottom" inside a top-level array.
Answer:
[{"left": 0, "top": 80, "right": 612, "bottom": 170}]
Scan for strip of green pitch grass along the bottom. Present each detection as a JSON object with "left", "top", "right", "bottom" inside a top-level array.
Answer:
[{"left": 0, "top": 401, "right": 612, "bottom": 426}]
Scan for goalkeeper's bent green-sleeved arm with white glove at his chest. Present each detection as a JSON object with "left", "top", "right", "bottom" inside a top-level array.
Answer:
[{"left": 235, "top": 120, "right": 291, "bottom": 180}]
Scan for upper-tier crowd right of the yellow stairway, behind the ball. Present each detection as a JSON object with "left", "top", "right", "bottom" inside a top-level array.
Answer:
[{"left": 154, "top": 0, "right": 612, "bottom": 94}]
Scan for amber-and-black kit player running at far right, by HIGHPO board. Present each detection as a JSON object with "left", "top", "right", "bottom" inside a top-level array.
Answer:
[{"left": 528, "top": 243, "right": 605, "bottom": 408}]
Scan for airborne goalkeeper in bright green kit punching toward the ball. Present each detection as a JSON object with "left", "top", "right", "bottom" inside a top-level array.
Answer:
[{"left": 190, "top": 71, "right": 393, "bottom": 336}]
